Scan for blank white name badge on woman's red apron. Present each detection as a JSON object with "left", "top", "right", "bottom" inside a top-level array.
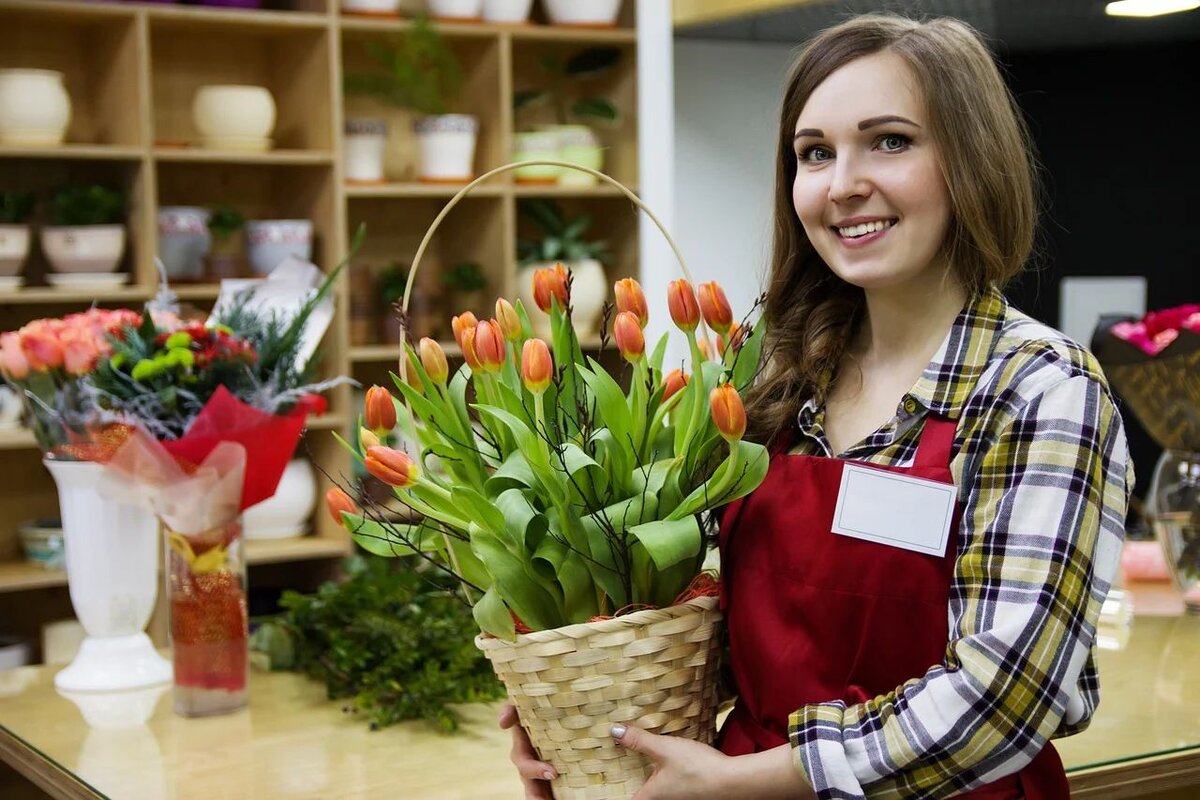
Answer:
[{"left": 833, "top": 464, "right": 955, "bottom": 555}]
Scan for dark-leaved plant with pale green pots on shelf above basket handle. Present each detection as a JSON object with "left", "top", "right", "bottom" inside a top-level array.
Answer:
[{"left": 512, "top": 47, "right": 622, "bottom": 186}]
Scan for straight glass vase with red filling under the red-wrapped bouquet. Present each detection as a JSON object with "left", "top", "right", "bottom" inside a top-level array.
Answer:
[{"left": 164, "top": 517, "right": 250, "bottom": 717}]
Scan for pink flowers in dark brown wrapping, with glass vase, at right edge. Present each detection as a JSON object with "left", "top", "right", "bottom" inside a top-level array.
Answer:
[{"left": 1092, "top": 305, "right": 1200, "bottom": 609}]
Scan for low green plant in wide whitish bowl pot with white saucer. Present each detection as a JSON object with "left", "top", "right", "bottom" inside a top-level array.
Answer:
[{"left": 41, "top": 184, "right": 125, "bottom": 285}]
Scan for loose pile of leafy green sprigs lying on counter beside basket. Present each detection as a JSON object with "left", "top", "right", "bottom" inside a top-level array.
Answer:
[{"left": 252, "top": 555, "right": 504, "bottom": 732}]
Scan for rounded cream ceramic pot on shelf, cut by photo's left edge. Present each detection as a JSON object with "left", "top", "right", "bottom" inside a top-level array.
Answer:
[{"left": 0, "top": 70, "right": 71, "bottom": 146}]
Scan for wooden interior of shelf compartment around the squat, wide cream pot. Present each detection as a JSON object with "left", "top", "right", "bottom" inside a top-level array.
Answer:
[{"left": 150, "top": 21, "right": 334, "bottom": 152}]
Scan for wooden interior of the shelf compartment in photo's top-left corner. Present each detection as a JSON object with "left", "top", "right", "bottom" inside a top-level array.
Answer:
[{"left": 0, "top": 4, "right": 145, "bottom": 146}]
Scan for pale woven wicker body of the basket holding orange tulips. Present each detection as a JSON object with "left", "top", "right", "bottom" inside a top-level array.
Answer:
[{"left": 475, "top": 597, "right": 721, "bottom": 800}]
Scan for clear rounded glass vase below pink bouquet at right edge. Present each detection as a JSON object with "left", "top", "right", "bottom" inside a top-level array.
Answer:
[{"left": 1148, "top": 450, "right": 1200, "bottom": 614}]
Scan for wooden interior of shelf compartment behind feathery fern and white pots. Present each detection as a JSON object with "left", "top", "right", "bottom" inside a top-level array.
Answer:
[{"left": 342, "top": 26, "right": 509, "bottom": 183}]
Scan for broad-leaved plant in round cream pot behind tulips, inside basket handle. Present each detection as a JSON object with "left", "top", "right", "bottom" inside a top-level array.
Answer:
[{"left": 517, "top": 199, "right": 612, "bottom": 338}]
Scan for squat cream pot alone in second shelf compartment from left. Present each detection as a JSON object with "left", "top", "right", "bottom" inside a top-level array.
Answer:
[{"left": 192, "top": 85, "right": 275, "bottom": 151}]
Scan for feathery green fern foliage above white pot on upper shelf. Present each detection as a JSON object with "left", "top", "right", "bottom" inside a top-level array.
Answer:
[{"left": 343, "top": 16, "right": 462, "bottom": 114}]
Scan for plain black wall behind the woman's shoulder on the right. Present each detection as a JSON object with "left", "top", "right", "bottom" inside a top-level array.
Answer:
[{"left": 1001, "top": 42, "right": 1200, "bottom": 510}]
